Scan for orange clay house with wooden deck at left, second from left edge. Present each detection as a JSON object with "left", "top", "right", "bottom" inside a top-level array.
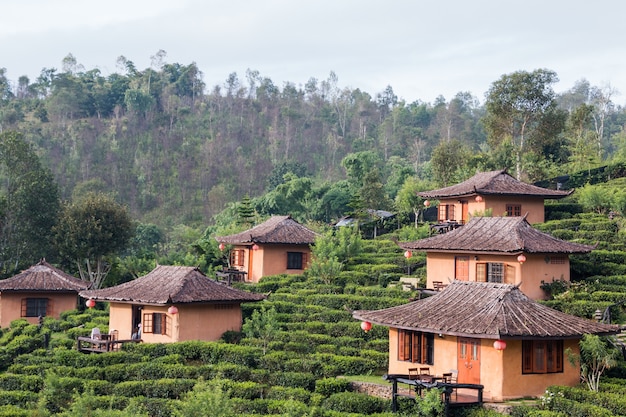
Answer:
[{"left": 80, "top": 265, "right": 265, "bottom": 343}]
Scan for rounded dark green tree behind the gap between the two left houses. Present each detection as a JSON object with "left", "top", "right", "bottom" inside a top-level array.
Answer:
[{"left": 55, "top": 194, "right": 134, "bottom": 289}]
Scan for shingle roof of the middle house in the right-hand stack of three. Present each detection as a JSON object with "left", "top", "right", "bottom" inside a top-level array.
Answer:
[{"left": 399, "top": 217, "right": 594, "bottom": 254}]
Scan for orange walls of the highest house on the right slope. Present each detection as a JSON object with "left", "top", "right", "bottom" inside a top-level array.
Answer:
[{"left": 439, "top": 195, "right": 545, "bottom": 224}]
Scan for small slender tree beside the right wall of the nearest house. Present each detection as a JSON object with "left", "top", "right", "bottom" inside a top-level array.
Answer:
[{"left": 565, "top": 334, "right": 619, "bottom": 391}]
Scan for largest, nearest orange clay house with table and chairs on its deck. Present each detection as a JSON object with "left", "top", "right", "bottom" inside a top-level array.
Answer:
[{"left": 353, "top": 280, "right": 618, "bottom": 402}]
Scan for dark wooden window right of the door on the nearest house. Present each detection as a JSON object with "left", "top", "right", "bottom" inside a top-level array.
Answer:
[{"left": 522, "top": 340, "right": 563, "bottom": 374}]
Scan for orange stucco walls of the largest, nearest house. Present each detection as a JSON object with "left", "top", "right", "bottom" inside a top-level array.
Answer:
[{"left": 388, "top": 328, "right": 580, "bottom": 401}]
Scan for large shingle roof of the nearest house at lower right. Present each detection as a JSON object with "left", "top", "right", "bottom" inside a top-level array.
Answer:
[{"left": 352, "top": 281, "right": 619, "bottom": 339}]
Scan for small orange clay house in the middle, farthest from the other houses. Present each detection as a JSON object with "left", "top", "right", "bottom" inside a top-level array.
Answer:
[{"left": 215, "top": 216, "right": 317, "bottom": 282}]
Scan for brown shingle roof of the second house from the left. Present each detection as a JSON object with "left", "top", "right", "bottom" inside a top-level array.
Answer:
[{"left": 79, "top": 265, "right": 265, "bottom": 304}]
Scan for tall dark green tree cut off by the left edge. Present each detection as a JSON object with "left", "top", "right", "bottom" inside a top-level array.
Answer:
[{"left": 0, "top": 132, "right": 60, "bottom": 274}]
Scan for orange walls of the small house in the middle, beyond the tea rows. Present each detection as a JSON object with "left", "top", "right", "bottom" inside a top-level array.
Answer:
[{"left": 234, "top": 244, "right": 311, "bottom": 282}]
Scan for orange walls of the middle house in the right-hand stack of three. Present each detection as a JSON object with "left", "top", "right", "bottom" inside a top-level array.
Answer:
[{"left": 426, "top": 252, "right": 570, "bottom": 300}]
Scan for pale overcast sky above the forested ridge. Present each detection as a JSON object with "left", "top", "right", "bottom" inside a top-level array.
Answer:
[{"left": 0, "top": 0, "right": 626, "bottom": 105}]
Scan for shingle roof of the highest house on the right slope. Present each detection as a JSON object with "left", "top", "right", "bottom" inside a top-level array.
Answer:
[{"left": 417, "top": 170, "right": 573, "bottom": 199}]
